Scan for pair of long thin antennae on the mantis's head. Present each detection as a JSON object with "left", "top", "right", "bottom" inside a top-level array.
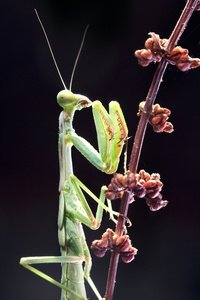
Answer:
[{"left": 34, "top": 9, "right": 89, "bottom": 91}]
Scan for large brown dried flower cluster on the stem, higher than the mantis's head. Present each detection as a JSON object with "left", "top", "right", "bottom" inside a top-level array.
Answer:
[{"left": 135, "top": 31, "right": 200, "bottom": 71}]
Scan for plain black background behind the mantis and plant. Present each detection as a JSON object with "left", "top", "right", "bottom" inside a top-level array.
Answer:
[{"left": 0, "top": 0, "right": 200, "bottom": 300}]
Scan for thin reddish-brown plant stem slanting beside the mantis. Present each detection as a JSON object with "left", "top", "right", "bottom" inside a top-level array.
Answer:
[{"left": 105, "top": 0, "right": 198, "bottom": 300}]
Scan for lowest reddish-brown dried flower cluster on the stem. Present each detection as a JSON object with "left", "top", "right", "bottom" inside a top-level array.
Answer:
[{"left": 91, "top": 228, "right": 137, "bottom": 263}]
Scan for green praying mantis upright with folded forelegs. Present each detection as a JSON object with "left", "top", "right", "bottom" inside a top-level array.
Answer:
[{"left": 20, "top": 12, "right": 128, "bottom": 300}]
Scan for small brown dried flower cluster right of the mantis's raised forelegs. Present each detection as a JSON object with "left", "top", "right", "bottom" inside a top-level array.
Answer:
[{"left": 137, "top": 101, "right": 174, "bottom": 133}]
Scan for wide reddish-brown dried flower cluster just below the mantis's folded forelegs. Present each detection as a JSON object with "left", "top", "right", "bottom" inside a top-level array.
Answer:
[{"left": 105, "top": 170, "right": 168, "bottom": 211}]
